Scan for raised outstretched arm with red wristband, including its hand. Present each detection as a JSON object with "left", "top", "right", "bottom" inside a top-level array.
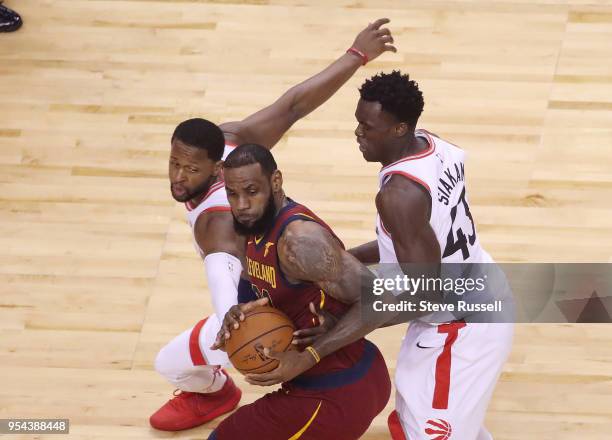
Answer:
[{"left": 220, "top": 18, "right": 396, "bottom": 148}]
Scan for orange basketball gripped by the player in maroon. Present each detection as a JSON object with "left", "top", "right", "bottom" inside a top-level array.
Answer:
[{"left": 225, "top": 306, "right": 295, "bottom": 374}]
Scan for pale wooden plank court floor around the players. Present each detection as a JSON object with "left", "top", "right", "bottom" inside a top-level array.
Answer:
[{"left": 0, "top": 0, "right": 612, "bottom": 440}]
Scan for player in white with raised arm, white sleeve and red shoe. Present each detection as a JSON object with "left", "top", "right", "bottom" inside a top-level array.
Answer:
[{"left": 150, "top": 19, "right": 396, "bottom": 431}]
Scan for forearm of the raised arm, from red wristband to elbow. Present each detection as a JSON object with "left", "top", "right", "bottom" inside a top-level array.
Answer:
[{"left": 287, "top": 53, "right": 362, "bottom": 119}]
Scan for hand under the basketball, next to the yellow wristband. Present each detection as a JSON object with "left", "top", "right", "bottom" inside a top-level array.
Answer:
[{"left": 244, "top": 347, "right": 316, "bottom": 387}]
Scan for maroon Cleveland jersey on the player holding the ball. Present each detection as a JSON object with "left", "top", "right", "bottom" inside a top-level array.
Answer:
[{"left": 246, "top": 199, "right": 364, "bottom": 376}]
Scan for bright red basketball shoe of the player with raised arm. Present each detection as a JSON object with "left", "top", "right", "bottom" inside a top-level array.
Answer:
[{"left": 149, "top": 374, "right": 242, "bottom": 431}]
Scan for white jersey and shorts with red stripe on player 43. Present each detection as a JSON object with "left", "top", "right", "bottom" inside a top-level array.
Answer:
[{"left": 377, "top": 130, "right": 513, "bottom": 440}]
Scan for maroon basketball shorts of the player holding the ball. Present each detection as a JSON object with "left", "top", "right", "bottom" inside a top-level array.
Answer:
[{"left": 208, "top": 341, "right": 391, "bottom": 440}]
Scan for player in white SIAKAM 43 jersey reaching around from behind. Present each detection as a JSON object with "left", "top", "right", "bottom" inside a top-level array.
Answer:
[{"left": 247, "top": 71, "right": 513, "bottom": 440}]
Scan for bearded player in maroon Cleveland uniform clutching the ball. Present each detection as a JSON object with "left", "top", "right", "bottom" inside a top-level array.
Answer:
[{"left": 209, "top": 144, "right": 391, "bottom": 440}]
